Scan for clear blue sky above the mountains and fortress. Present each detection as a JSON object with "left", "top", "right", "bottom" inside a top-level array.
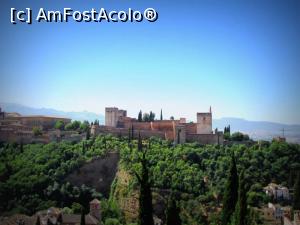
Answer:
[{"left": 0, "top": 0, "right": 300, "bottom": 124}]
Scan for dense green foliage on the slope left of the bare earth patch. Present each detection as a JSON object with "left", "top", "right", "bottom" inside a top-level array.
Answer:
[{"left": 0, "top": 137, "right": 122, "bottom": 214}]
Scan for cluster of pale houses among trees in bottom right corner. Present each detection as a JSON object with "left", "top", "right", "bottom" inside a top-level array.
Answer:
[{"left": 258, "top": 183, "right": 300, "bottom": 225}]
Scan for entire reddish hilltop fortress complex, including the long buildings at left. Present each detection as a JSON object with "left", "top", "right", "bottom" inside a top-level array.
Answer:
[{"left": 0, "top": 107, "right": 223, "bottom": 144}]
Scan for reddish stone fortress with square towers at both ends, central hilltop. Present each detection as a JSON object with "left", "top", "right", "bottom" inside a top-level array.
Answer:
[{"left": 91, "top": 107, "right": 223, "bottom": 144}]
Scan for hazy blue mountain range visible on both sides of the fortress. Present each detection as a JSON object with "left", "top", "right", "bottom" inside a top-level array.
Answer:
[{"left": 0, "top": 103, "right": 300, "bottom": 143}]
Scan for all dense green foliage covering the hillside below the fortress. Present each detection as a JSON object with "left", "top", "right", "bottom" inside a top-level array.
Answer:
[{"left": 0, "top": 135, "right": 300, "bottom": 224}]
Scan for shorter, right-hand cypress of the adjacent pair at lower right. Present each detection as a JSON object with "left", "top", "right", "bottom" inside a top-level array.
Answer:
[{"left": 232, "top": 171, "right": 247, "bottom": 225}]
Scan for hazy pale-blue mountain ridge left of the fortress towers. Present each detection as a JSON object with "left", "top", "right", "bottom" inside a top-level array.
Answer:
[{"left": 0, "top": 103, "right": 104, "bottom": 123}]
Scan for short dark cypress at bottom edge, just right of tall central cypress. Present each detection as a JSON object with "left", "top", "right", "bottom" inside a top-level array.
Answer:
[{"left": 166, "top": 193, "right": 181, "bottom": 225}]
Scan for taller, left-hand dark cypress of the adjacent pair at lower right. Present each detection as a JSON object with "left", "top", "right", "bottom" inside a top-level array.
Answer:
[{"left": 221, "top": 154, "right": 238, "bottom": 225}]
